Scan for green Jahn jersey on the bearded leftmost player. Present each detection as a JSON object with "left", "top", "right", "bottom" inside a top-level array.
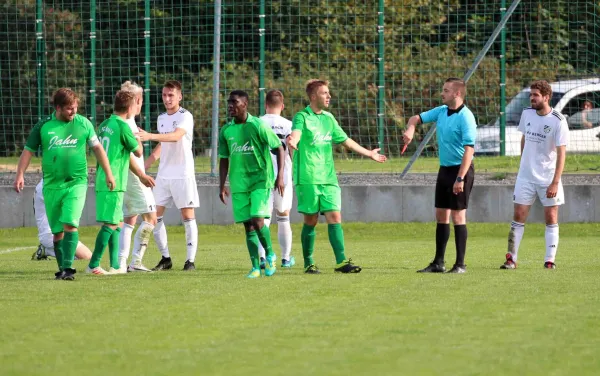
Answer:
[{"left": 25, "top": 113, "right": 98, "bottom": 189}]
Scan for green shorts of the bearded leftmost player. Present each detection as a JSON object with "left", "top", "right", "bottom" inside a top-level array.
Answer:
[{"left": 42, "top": 184, "right": 87, "bottom": 234}]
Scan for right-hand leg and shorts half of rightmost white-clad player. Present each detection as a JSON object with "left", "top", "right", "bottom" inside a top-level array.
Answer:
[{"left": 536, "top": 183, "right": 565, "bottom": 269}]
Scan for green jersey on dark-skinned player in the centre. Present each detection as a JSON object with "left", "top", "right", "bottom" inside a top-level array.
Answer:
[{"left": 219, "top": 114, "right": 281, "bottom": 193}]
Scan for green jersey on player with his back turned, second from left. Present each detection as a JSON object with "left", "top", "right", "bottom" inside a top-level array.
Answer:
[{"left": 96, "top": 114, "right": 139, "bottom": 192}]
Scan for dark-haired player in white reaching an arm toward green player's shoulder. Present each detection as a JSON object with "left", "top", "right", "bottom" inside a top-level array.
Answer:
[{"left": 139, "top": 81, "right": 200, "bottom": 271}]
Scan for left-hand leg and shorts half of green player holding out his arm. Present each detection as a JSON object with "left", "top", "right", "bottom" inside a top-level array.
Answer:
[{"left": 296, "top": 184, "right": 321, "bottom": 274}]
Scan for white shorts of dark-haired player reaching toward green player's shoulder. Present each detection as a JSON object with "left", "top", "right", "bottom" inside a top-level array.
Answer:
[{"left": 153, "top": 176, "right": 200, "bottom": 209}]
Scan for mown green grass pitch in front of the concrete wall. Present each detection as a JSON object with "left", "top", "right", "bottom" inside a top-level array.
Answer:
[{"left": 0, "top": 224, "right": 600, "bottom": 375}]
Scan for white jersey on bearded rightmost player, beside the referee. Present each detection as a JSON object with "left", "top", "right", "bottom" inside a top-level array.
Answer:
[{"left": 517, "top": 108, "right": 569, "bottom": 184}]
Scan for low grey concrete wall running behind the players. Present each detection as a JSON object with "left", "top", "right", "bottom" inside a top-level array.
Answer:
[{"left": 0, "top": 185, "right": 600, "bottom": 227}]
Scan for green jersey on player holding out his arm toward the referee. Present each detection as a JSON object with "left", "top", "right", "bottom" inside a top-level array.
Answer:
[{"left": 292, "top": 106, "right": 348, "bottom": 185}]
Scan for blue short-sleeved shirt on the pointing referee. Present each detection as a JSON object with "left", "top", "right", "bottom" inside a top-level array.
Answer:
[{"left": 419, "top": 104, "right": 477, "bottom": 167}]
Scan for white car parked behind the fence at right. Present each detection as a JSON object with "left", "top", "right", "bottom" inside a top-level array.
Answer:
[{"left": 475, "top": 78, "right": 600, "bottom": 156}]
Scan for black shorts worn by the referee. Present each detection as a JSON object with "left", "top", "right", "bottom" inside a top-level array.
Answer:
[{"left": 435, "top": 165, "right": 475, "bottom": 210}]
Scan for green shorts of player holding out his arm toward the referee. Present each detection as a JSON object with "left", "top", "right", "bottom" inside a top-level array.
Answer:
[{"left": 296, "top": 184, "right": 342, "bottom": 214}]
